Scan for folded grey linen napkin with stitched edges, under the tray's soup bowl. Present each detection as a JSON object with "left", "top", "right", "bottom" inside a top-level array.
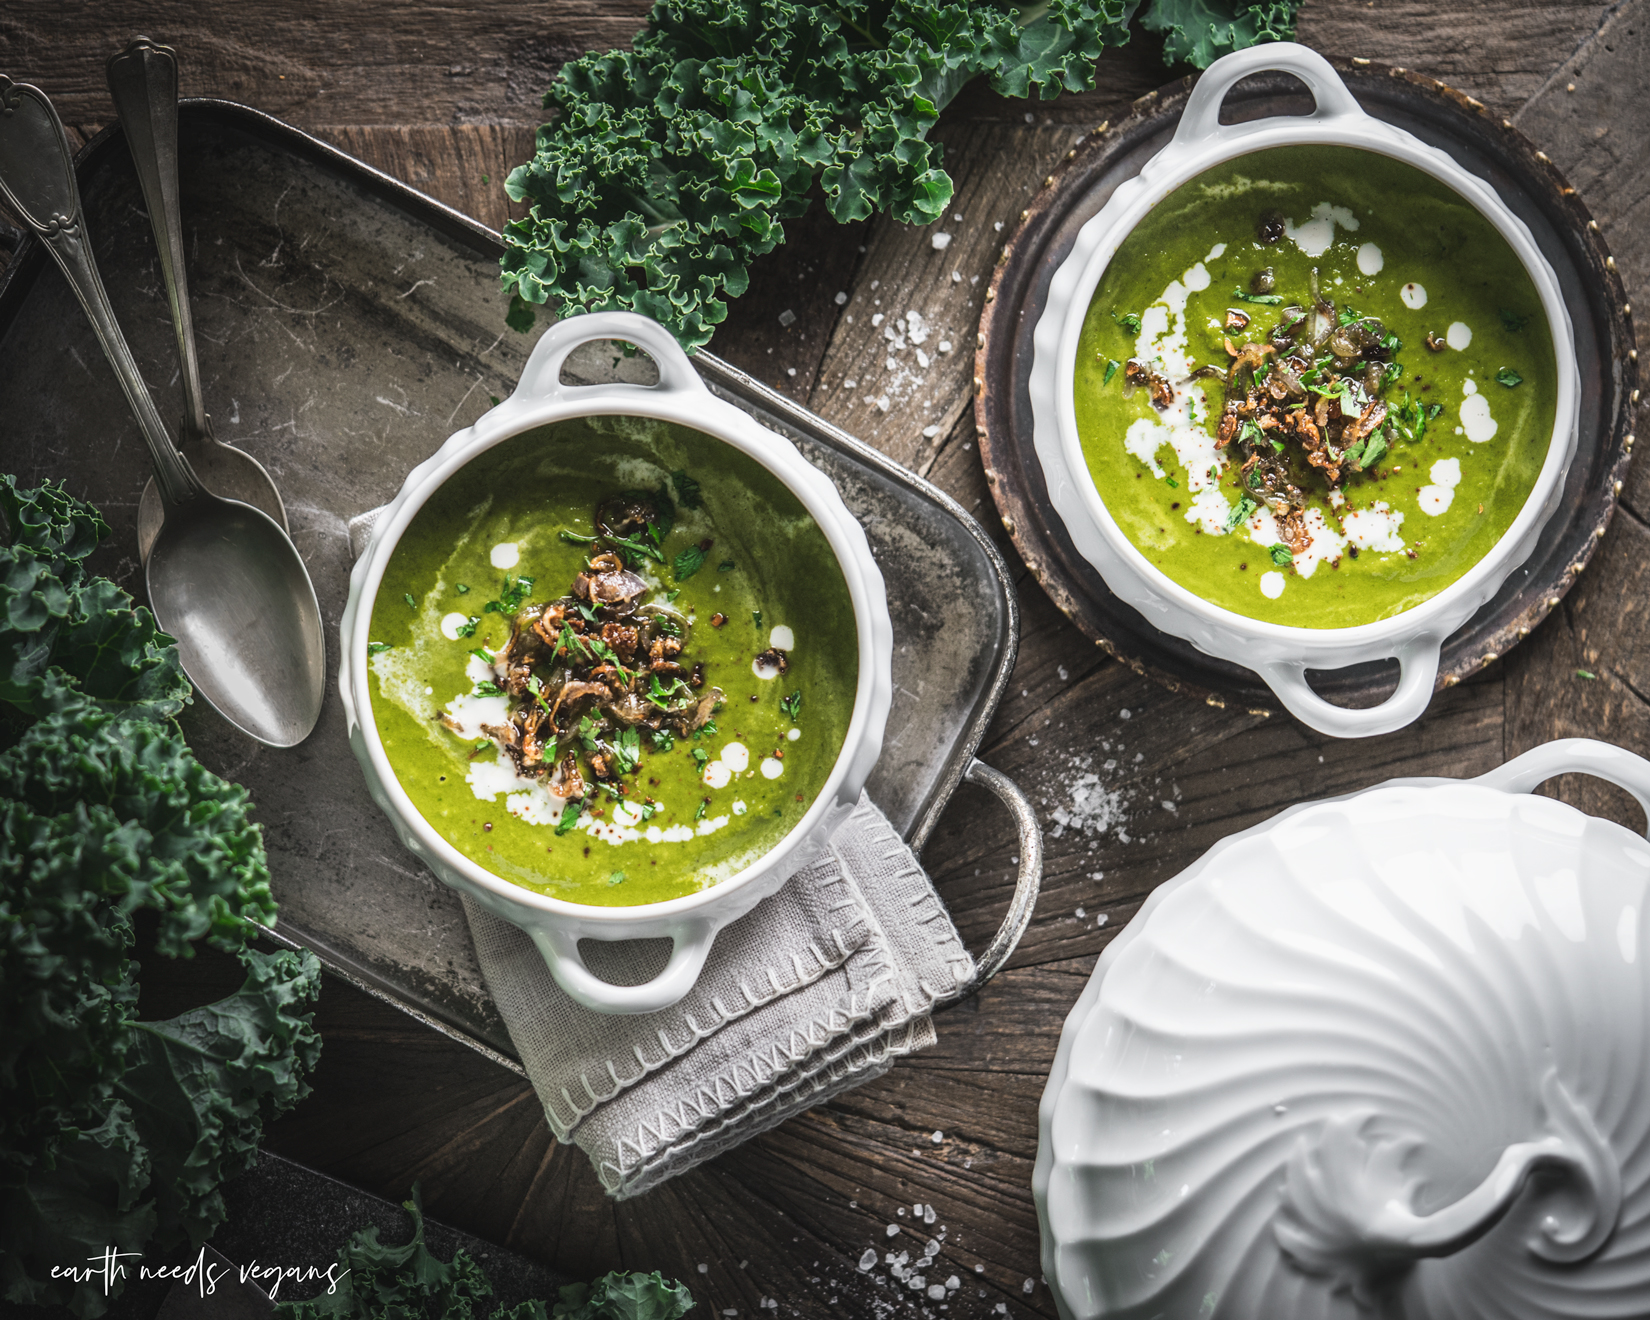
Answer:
[{"left": 464, "top": 797, "right": 974, "bottom": 1200}]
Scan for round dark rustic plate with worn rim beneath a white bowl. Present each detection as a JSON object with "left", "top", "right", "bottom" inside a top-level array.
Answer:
[{"left": 974, "top": 59, "right": 1638, "bottom": 711}]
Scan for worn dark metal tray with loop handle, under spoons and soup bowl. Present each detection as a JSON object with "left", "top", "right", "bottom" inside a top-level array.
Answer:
[{"left": 0, "top": 101, "right": 1041, "bottom": 1063}]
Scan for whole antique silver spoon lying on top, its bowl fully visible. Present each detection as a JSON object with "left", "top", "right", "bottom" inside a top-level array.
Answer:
[{"left": 0, "top": 74, "right": 327, "bottom": 747}]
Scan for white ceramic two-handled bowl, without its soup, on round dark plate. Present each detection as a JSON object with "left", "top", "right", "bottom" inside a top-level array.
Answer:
[{"left": 1030, "top": 43, "right": 1581, "bottom": 738}]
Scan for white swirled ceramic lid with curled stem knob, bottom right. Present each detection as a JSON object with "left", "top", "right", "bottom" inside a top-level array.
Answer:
[{"left": 1036, "top": 741, "right": 1650, "bottom": 1320}]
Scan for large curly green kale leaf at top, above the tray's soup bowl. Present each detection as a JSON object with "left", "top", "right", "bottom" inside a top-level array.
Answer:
[{"left": 503, "top": 0, "right": 1137, "bottom": 350}]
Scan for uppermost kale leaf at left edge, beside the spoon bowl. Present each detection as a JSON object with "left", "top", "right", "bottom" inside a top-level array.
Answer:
[{"left": 0, "top": 475, "right": 190, "bottom": 718}]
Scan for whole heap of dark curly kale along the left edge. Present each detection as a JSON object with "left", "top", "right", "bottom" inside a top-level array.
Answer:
[{"left": 0, "top": 477, "right": 320, "bottom": 1317}]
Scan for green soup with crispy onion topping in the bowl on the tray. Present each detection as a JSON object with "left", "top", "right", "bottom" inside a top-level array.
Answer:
[{"left": 368, "top": 416, "right": 858, "bottom": 906}]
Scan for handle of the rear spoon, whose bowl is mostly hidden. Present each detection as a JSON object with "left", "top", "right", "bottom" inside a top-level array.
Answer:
[{"left": 107, "top": 36, "right": 210, "bottom": 441}]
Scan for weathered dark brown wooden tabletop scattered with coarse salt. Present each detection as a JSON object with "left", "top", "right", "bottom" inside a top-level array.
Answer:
[{"left": 0, "top": 0, "right": 1650, "bottom": 1317}]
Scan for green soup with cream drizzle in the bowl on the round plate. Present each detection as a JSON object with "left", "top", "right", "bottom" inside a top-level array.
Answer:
[{"left": 1076, "top": 147, "right": 1558, "bottom": 629}]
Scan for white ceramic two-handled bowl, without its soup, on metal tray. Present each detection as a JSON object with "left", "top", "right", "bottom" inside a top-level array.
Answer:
[{"left": 338, "top": 312, "right": 894, "bottom": 1013}]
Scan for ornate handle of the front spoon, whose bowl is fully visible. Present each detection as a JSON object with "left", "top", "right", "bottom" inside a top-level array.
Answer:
[{"left": 0, "top": 74, "right": 201, "bottom": 507}]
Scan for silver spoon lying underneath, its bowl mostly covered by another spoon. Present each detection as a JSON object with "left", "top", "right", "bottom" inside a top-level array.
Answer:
[{"left": 107, "top": 36, "right": 289, "bottom": 563}]
